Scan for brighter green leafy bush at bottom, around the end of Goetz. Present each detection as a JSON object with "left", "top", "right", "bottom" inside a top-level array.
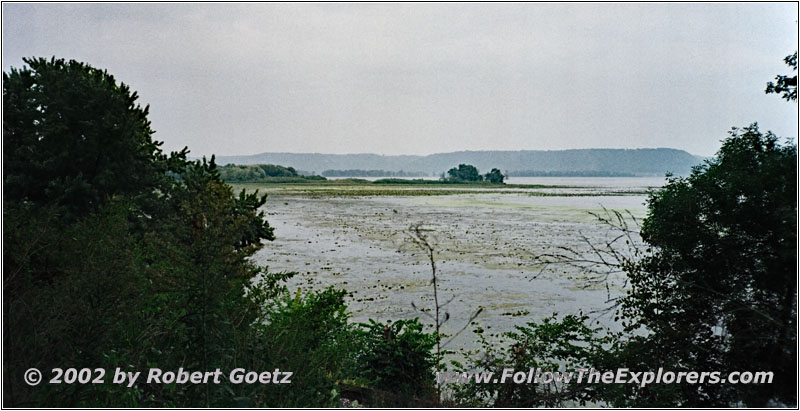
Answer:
[{"left": 237, "top": 288, "right": 359, "bottom": 407}]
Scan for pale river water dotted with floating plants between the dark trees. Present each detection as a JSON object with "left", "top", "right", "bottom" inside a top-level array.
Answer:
[{"left": 255, "top": 177, "right": 663, "bottom": 349}]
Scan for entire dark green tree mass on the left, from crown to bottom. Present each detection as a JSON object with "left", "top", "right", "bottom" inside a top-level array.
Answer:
[{"left": 3, "top": 59, "right": 274, "bottom": 407}]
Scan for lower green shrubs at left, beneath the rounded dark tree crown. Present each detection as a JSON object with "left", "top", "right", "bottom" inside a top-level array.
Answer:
[{"left": 3, "top": 157, "right": 274, "bottom": 406}]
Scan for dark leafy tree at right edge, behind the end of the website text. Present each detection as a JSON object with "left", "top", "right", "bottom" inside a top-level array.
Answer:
[{"left": 622, "top": 124, "right": 797, "bottom": 406}]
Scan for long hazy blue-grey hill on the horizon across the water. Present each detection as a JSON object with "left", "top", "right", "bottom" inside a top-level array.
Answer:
[{"left": 211, "top": 148, "right": 702, "bottom": 176}]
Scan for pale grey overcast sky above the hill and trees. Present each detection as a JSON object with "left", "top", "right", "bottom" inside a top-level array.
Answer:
[{"left": 2, "top": 3, "right": 798, "bottom": 156}]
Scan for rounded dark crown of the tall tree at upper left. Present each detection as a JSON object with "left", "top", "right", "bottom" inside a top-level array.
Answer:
[{"left": 3, "top": 58, "right": 187, "bottom": 219}]
